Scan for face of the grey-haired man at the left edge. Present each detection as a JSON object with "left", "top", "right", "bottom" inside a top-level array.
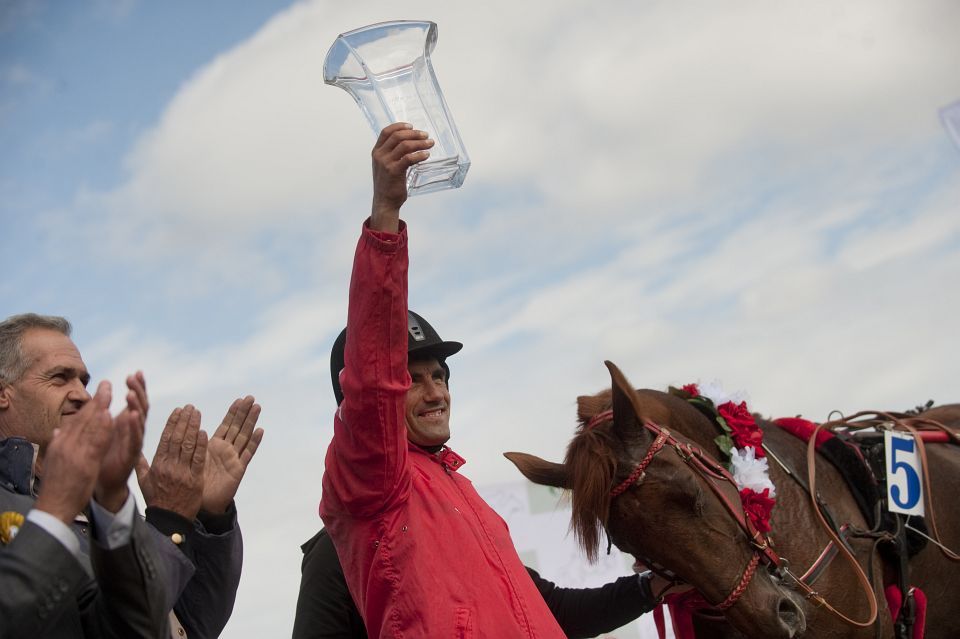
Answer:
[{"left": 0, "top": 328, "right": 90, "bottom": 455}]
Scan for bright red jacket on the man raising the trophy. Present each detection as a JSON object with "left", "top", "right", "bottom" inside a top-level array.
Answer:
[{"left": 320, "top": 222, "right": 564, "bottom": 639}]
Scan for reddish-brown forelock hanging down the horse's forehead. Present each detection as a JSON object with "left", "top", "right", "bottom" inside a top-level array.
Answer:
[{"left": 564, "top": 390, "right": 617, "bottom": 563}]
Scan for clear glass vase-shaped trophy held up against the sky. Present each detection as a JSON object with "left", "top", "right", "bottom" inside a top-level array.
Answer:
[{"left": 323, "top": 20, "right": 470, "bottom": 195}]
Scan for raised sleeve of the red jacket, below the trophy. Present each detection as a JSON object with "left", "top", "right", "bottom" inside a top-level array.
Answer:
[{"left": 322, "top": 222, "right": 410, "bottom": 517}]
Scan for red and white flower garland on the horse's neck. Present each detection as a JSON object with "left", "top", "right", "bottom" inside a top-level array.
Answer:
[{"left": 670, "top": 384, "right": 777, "bottom": 533}]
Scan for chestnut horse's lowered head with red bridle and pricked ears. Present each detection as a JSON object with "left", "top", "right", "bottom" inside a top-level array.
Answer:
[{"left": 506, "top": 362, "right": 805, "bottom": 639}]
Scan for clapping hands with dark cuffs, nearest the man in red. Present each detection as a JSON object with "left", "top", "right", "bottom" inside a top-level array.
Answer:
[{"left": 136, "top": 384, "right": 263, "bottom": 520}]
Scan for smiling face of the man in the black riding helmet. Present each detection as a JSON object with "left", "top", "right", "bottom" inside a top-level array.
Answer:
[{"left": 406, "top": 359, "right": 450, "bottom": 446}]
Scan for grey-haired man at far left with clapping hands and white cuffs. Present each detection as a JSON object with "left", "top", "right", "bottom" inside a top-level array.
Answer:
[{"left": 0, "top": 323, "right": 167, "bottom": 639}]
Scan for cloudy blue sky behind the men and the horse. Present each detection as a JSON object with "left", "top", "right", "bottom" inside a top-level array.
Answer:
[{"left": 0, "top": 0, "right": 960, "bottom": 637}]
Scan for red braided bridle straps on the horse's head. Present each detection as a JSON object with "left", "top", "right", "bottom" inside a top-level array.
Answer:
[{"left": 587, "top": 410, "right": 785, "bottom": 610}]
